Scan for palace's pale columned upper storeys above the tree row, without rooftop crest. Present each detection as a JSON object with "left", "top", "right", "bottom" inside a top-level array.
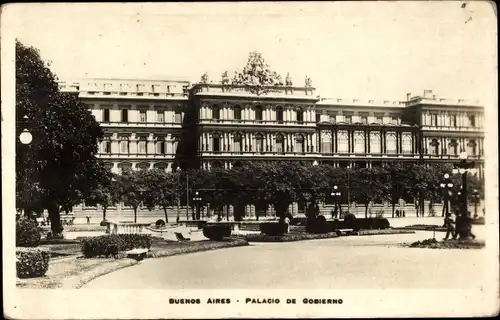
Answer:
[{"left": 60, "top": 75, "right": 485, "bottom": 177}]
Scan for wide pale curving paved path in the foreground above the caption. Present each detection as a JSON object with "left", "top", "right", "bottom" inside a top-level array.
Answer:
[{"left": 83, "top": 232, "right": 487, "bottom": 289}]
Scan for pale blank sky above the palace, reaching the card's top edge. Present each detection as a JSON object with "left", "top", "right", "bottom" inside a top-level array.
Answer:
[{"left": 5, "top": 1, "right": 497, "bottom": 101}]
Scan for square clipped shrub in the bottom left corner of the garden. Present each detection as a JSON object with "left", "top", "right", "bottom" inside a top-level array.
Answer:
[{"left": 16, "top": 247, "right": 50, "bottom": 278}]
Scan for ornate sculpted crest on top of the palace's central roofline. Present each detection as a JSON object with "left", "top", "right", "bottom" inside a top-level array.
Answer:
[{"left": 232, "top": 51, "right": 283, "bottom": 95}]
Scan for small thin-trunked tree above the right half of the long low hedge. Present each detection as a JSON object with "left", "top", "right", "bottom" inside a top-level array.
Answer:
[{"left": 117, "top": 171, "right": 147, "bottom": 223}]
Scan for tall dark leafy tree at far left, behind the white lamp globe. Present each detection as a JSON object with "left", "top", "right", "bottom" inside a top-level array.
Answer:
[{"left": 16, "top": 41, "right": 103, "bottom": 234}]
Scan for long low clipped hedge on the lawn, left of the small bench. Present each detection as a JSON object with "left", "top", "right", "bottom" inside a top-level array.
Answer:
[{"left": 81, "top": 234, "right": 151, "bottom": 258}]
